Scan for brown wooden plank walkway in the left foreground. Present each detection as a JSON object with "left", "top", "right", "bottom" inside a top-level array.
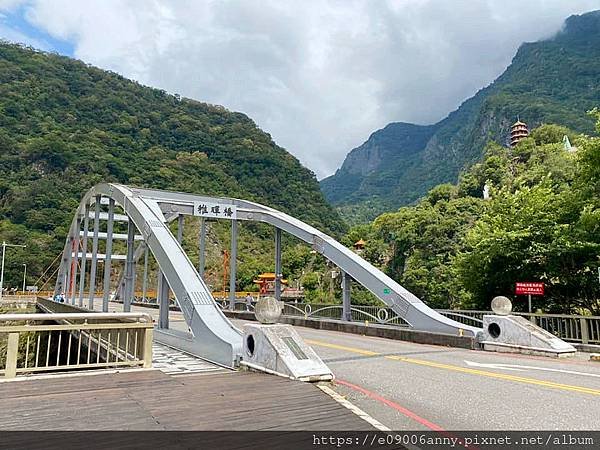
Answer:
[{"left": 0, "top": 370, "right": 371, "bottom": 431}]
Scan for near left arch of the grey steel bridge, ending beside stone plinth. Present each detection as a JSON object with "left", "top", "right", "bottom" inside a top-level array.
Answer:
[{"left": 55, "top": 184, "right": 242, "bottom": 367}]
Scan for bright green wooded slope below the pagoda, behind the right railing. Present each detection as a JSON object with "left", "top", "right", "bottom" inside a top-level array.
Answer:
[{"left": 346, "top": 115, "right": 600, "bottom": 315}]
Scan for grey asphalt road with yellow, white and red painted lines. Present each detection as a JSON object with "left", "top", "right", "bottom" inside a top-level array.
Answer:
[{"left": 96, "top": 302, "right": 600, "bottom": 431}]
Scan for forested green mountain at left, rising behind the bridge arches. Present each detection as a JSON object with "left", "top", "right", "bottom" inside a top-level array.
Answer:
[{"left": 0, "top": 42, "right": 344, "bottom": 281}]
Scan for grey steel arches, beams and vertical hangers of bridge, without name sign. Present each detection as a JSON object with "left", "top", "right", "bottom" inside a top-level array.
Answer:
[{"left": 56, "top": 184, "right": 481, "bottom": 366}]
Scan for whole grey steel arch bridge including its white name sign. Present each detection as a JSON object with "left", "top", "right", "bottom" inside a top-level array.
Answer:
[{"left": 55, "top": 184, "right": 481, "bottom": 367}]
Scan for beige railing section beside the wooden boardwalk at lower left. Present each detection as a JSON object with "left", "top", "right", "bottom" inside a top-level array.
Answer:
[{"left": 0, "top": 313, "right": 154, "bottom": 378}]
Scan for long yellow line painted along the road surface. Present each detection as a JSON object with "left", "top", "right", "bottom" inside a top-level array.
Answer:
[{"left": 306, "top": 339, "right": 600, "bottom": 395}]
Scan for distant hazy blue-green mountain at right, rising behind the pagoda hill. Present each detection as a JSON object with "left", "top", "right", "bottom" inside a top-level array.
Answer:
[{"left": 321, "top": 11, "right": 600, "bottom": 222}]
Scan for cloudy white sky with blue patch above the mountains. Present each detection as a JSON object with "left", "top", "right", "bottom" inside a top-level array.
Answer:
[{"left": 0, "top": 0, "right": 600, "bottom": 178}]
